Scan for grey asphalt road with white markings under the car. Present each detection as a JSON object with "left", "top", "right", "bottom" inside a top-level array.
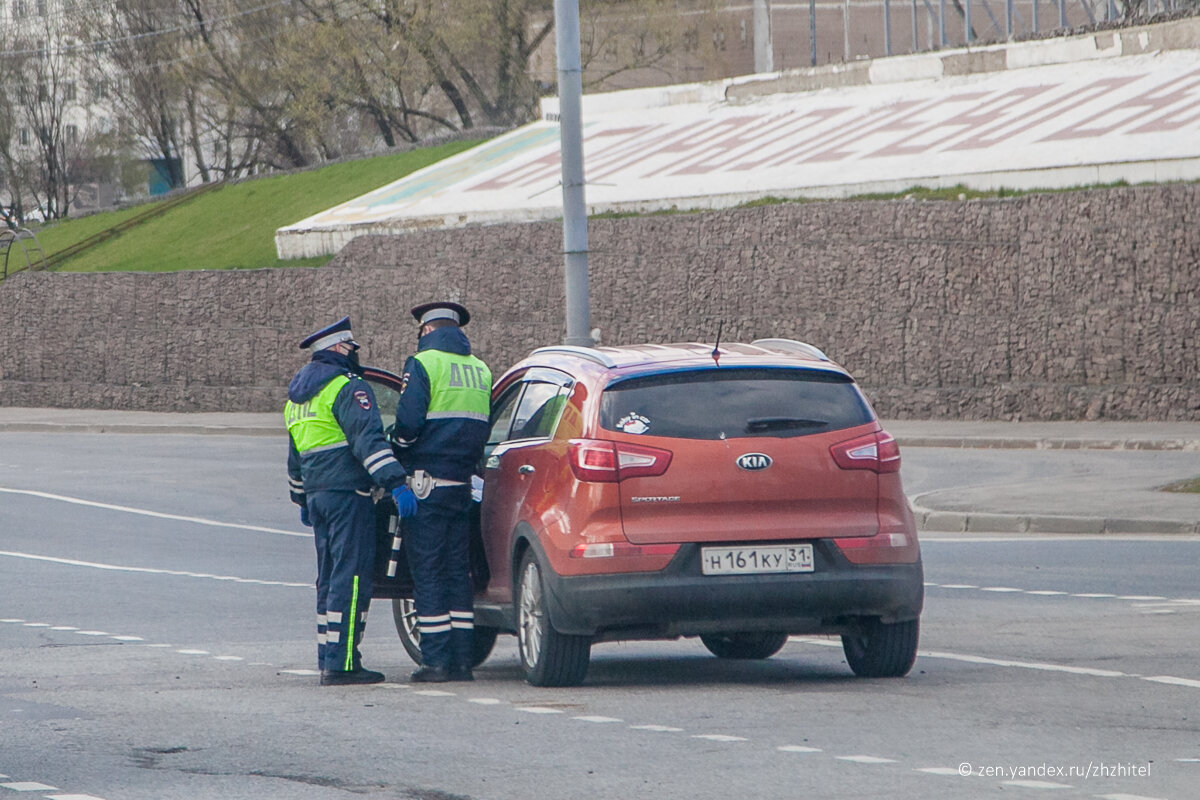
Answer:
[{"left": 0, "top": 433, "right": 1200, "bottom": 800}]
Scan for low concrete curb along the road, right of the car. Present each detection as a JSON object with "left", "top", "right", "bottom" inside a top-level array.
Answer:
[{"left": 912, "top": 506, "right": 1200, "bottom": 534}]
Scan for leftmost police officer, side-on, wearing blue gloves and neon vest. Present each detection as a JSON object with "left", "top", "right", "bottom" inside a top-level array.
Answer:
[{"left": 283, "top": 317, "right": 416, "bottom": 686}]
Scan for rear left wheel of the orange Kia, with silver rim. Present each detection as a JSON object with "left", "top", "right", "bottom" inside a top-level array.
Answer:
[{"left": 517, "top": 553, "right": 592, "bottom": 686}]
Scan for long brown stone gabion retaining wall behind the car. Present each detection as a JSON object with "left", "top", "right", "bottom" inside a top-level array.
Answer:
[{"left": 0, "top": 185, "right": 1200, "bottom": 420}]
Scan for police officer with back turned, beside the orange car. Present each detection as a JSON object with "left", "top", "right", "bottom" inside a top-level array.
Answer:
[{"left": 391, "top": 302, "right": 492, "bottom": 682}]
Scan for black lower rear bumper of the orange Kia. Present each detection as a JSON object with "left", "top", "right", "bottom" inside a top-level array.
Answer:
[{"left": 542, "top": 541, "right": 925, "bottom": 639}]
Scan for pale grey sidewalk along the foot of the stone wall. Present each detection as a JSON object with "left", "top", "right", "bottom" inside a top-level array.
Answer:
[{"left": 0, "top": 407, "right": 1200, "bottom": 534}]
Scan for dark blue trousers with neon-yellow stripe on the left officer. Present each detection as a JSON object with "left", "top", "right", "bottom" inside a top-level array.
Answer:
[{"left": 308, "top": 492, "right": 374, "bottom": 672}]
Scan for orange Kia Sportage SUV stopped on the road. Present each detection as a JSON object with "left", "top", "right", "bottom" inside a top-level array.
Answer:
[{"left": 369, "top": 339, "right": 924, "bottom": 686}]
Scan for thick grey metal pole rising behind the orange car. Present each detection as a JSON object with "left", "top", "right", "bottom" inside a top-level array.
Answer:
[{"left": 554, "top": 0, "right": 593, "bottom": 347}]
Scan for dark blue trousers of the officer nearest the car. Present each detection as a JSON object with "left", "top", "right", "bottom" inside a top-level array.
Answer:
[{"left": 404, "top": 486, "right": 475, "bottom": 669}]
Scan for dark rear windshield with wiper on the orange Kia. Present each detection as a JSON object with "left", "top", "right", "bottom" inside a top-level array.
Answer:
[{"left": 600, "top": 368, "right": 875, "bottom": 439}]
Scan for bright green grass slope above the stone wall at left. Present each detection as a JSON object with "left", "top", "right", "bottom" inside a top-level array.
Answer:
[{"left": 35, "top": 140, "right": 479, "bottom": 272}]
